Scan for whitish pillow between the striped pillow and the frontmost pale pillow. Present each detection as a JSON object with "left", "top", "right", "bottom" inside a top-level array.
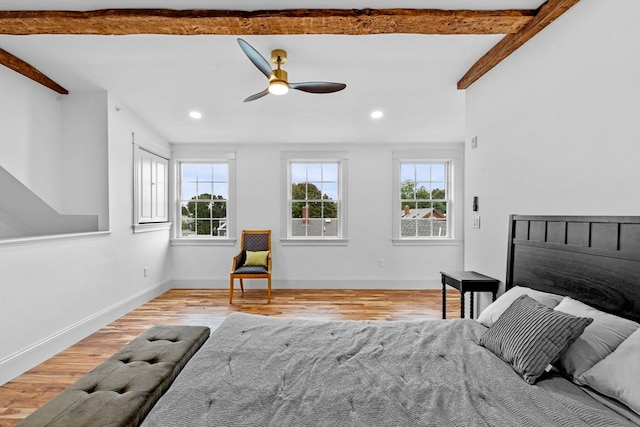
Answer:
[{"left": 555, "top": 297, "right": 640, "bottom": 380}]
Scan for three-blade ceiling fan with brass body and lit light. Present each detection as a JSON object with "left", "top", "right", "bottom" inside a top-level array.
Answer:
[{"left": 238, "top": 39, "right": 347, "bottom": 102}]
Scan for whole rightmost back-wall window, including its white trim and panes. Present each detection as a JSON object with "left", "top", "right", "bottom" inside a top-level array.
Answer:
[{"left": 393, "top": 150, "right": 462, "bottom": 243}]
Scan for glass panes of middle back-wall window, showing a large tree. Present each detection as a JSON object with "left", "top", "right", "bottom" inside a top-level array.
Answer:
[{"left": 290, "top": 162, "right": 339, "bottom": 237}]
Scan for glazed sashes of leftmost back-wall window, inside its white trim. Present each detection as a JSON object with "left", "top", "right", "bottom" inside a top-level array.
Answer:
[{"left": 178, "top": 162, "right": 229, "bottom": 238}]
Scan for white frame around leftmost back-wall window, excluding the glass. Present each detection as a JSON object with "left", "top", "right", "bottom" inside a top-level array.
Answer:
[{"left": 171, "top": 149, "right": 237, "bottom": 246}]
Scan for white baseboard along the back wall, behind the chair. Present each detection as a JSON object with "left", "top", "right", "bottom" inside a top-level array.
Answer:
[{"left": 169, "top": 277, "right": 442, "bottom": 290}]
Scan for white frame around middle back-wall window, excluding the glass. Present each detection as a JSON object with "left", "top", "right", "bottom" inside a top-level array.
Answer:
[{"left": 280, "top": 151, "right": 349, "bottom": 246}]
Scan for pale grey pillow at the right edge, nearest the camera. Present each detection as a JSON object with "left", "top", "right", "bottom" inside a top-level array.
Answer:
[{"left": 579, "top": 329, "right": 640, "bottom": 415}]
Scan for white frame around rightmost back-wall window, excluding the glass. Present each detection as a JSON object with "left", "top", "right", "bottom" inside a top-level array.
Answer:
[{"left": 391, "top": 143, "right": 464, "bottom": 245}]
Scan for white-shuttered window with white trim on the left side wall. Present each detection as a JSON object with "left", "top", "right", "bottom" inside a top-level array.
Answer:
[{"left": 132, "top": 143, "right": 171, "bottom": 233}]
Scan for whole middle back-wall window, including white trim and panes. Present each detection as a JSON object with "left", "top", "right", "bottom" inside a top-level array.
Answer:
[{"left": 285, "top": 153, "right": 346, "bottom": 243}]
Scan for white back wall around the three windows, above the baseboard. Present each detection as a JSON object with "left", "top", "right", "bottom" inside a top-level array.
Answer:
[{"left": 171, "top": 143, "right": 463, "bottom": 290}]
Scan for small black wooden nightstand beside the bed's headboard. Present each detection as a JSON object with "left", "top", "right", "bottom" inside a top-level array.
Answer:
[{"left": 440, "top": 271, "right": 500, "bottom": 319}]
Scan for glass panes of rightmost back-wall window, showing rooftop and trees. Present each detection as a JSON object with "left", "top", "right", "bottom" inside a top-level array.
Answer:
[{"left": 399, "top": 163, "right": 448, "bottom": 237}]
